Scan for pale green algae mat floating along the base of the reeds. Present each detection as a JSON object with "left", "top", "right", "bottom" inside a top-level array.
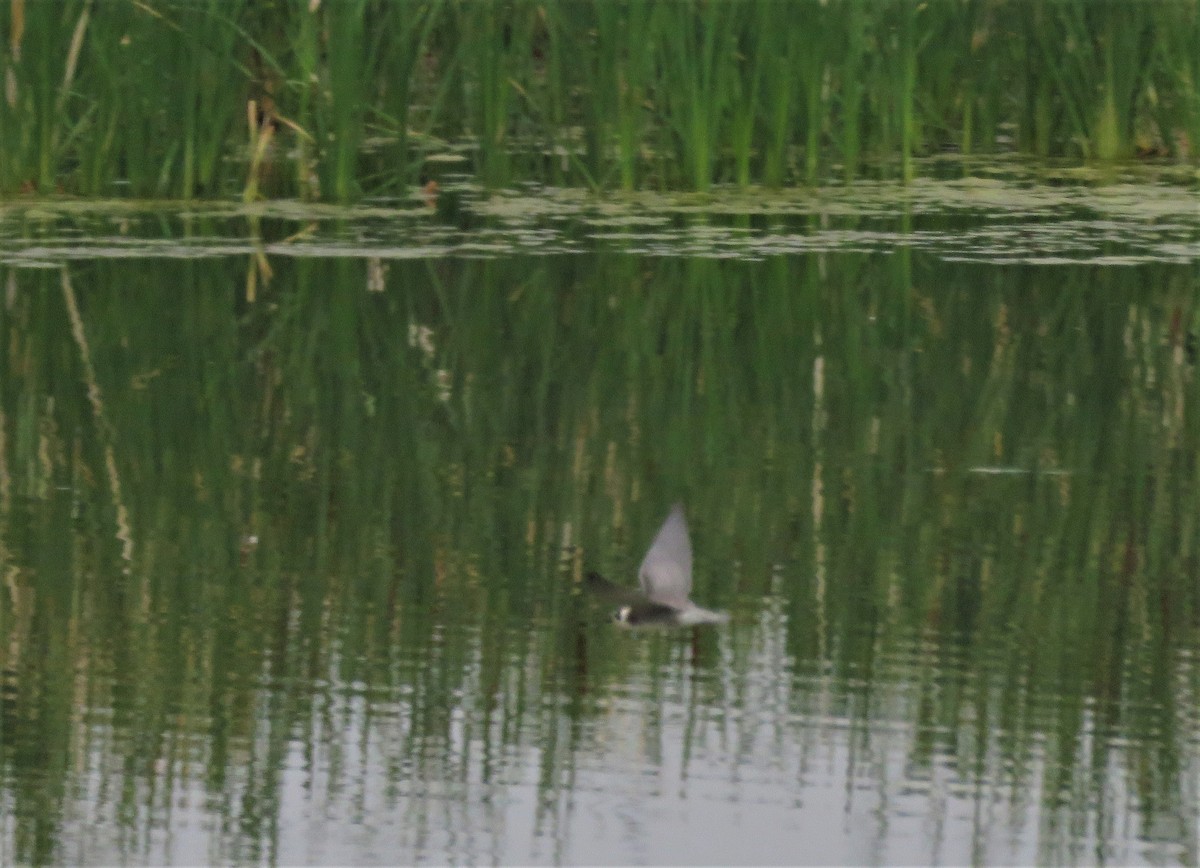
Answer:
[{"left": 0, "top": 164, "right": 1200, "bottom": 265}]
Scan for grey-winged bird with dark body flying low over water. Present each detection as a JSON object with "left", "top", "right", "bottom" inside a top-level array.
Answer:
[{"left": 587, "top": 503, "right": 730, "bottom": 627}]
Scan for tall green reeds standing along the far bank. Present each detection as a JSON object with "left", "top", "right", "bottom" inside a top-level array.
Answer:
[{"left": 0, "top": 0, "right": 1200, "bottom": 200}]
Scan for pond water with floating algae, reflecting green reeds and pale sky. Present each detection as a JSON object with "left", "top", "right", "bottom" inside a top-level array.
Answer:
[{"left": 0, "top": 166, "right": 1200, "bottom": 864}]
